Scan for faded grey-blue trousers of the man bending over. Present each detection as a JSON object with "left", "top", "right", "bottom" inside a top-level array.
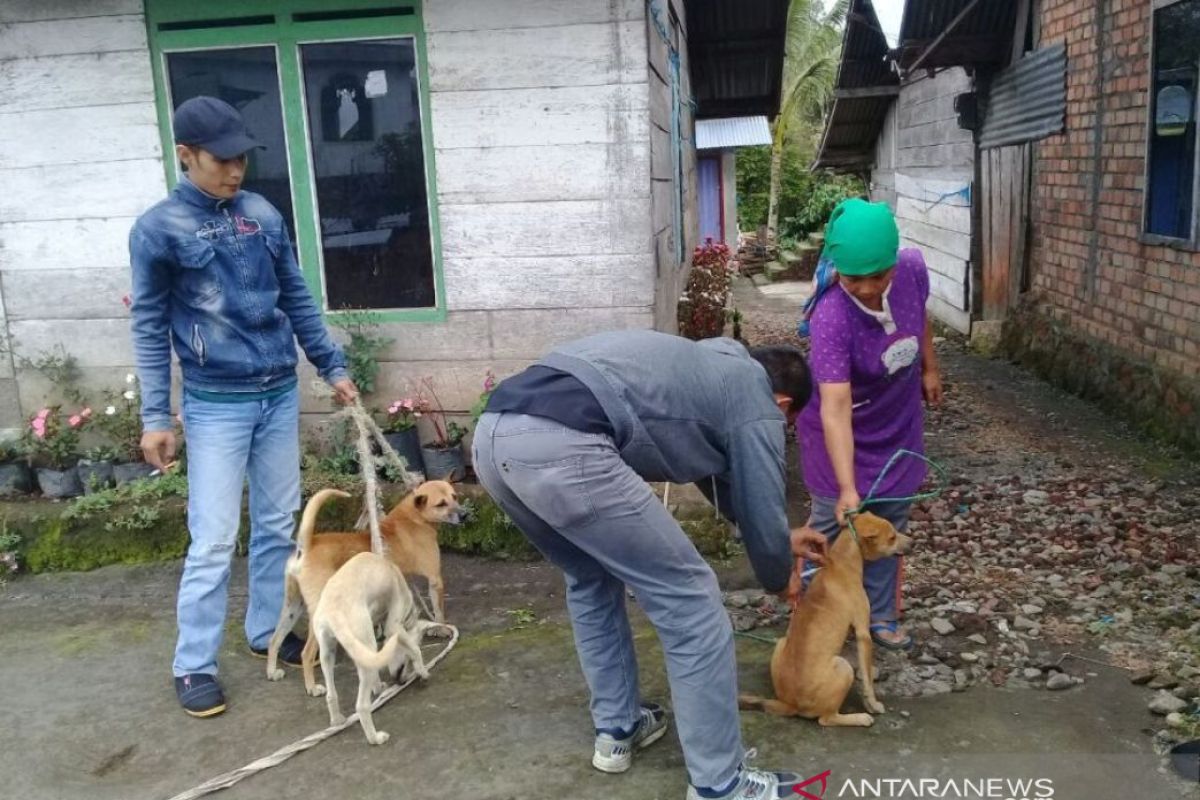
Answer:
[{"left": 473, "top": 414, "right": 744, "bottom": 787}]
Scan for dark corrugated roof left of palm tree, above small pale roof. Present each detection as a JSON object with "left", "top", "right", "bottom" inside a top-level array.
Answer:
[{"left": 684, "top": 0, "right": 788, "bottom": 118}]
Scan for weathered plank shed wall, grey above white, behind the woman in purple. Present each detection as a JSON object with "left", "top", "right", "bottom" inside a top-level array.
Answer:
[{"left": 871, "top": 68, "right": 974, "bottom": 333}]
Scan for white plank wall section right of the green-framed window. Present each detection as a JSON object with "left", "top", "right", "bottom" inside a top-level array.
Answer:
[{"left": 427, "top": 0, "right": 655, "bottom": 409}]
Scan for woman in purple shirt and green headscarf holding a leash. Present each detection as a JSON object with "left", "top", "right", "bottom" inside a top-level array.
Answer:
[{"left": 796, "top": 199, "right": 942, "bottom": 649}]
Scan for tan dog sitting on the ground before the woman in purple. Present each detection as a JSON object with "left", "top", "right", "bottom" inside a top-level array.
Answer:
[{"left": 738, "top": 513, "right": 912, "bottom": 727}]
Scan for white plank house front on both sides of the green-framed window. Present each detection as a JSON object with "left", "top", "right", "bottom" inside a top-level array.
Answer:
[{"left": 0, "top": 0, "right": 667, "bottom": 427}]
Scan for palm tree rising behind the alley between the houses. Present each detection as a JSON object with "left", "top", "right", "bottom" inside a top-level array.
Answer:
[{"left": 767, "top": 0, "right": 850, "bottom": 236}]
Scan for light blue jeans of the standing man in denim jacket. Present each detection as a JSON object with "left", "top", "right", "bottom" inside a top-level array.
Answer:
[{"left": 173, "top": 389, "right": 300, "bottom": 676}]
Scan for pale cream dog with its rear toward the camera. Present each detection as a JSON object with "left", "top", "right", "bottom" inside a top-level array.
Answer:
[{"left": 308, "top": 553, "right": 437, "bottom": 745}]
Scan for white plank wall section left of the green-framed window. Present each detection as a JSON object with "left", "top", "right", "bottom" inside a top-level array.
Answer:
[{"left": 0, "top": 0, "right": 166, "bottom": 428}]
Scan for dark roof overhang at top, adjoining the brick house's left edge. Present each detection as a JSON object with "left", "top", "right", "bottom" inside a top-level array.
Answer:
[{"left": 896, "top": 0, "right": 1018, "bottom": 68}]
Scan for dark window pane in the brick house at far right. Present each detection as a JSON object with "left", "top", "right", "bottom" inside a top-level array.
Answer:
[{"left": 1146, "top": 0, "right": 1200, "bottom": 239}]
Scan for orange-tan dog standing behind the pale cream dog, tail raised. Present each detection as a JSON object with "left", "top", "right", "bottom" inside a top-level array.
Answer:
[{"left": 266, "top": 481, "right": 462, "bottom": 697}]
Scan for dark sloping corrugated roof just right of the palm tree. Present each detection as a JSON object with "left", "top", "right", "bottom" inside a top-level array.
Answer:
[{"left": 815, "top": 0, "right": 900, "bottom": 169}]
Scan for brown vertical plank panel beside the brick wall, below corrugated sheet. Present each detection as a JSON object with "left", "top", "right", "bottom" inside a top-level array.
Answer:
[{"left": 979, "top": 143, "right": 1032, "bottom": 320}]
